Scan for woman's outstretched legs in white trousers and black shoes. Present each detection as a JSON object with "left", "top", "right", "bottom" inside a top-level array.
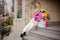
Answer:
[{"left": 20, "top": 18, "right": 37, "bottom": 38}]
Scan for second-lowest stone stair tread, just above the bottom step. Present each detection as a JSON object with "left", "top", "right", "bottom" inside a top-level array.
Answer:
[{"left": 30, "top": 30, "right": 60, "bottom": 39}]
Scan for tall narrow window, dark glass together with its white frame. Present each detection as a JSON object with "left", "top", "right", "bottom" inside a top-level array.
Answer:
[{"left": 14, "top": 0, "right": 25, "bottom": 19}]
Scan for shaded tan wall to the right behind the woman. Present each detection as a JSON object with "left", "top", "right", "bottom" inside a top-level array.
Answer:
[{"left": 39, "top": 0, "right": 60, "bottom": 21}]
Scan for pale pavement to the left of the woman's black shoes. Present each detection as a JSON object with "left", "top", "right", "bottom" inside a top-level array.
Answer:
[{"left": 3, "top": 26, "right": 21, "bottom": 40}]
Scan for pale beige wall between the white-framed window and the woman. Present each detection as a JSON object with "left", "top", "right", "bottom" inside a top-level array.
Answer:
[{"left": 12, "top": 0, "right": 34, "bottom": 31}]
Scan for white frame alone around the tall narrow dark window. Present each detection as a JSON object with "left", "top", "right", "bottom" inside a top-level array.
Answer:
[{"left": 14, "top": 0, "right": 25, "bottom": 20}]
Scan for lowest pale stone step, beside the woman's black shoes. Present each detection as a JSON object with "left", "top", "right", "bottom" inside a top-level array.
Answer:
[{"left": 25, "top": 33, "right": 59, "bottom": 40}]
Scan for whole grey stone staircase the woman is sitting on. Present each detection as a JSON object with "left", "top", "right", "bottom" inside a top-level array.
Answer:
[{"left": 25, "top": 26, "right": 60, "bottom": 40}]
